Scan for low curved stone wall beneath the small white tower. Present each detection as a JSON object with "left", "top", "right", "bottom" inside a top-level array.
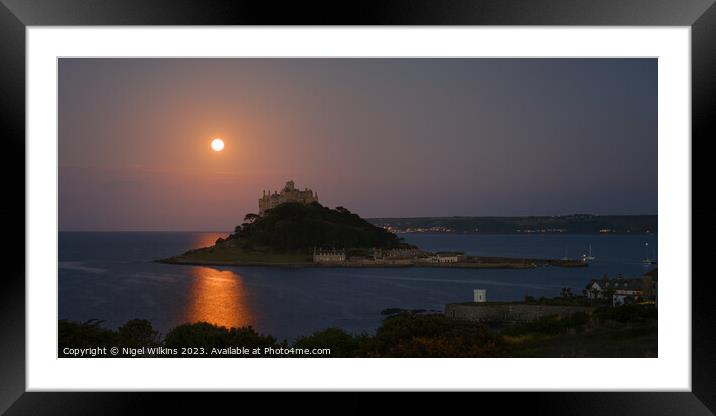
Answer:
[{"left": 445, "top": 303, "right": 593, "bottom": 322}]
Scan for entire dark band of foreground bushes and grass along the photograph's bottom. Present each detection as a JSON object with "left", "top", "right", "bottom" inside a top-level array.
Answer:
[{"left": 59, "top": 305, "right": 657, "bottom": 358}]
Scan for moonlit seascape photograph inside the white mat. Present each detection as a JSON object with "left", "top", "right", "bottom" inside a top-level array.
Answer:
[{"left": 56, "top": 57, "right": 660, "bottom": 359}]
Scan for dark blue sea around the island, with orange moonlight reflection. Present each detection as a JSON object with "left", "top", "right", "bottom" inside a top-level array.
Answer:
[{"left": 58, "top": 232, "right": 658, "bottom": 341}]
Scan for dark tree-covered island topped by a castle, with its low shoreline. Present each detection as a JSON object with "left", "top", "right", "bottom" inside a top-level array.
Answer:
[{"left": 159, "top": 181, "right": 587, "bottom": 268}]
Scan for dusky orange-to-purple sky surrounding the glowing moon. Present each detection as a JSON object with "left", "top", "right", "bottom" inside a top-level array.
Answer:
[{"left": 58, "top": 59, "right": 658, "bottom": 231}]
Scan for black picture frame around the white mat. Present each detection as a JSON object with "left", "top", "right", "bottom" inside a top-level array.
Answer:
[{"left": 0, "top": 0, "right": 716, "bottom": 415}]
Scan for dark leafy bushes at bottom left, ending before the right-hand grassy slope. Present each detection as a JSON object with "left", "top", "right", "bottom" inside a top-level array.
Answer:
[{"left": 59, "top": 314, "right": 506, "bottom": 357}]
